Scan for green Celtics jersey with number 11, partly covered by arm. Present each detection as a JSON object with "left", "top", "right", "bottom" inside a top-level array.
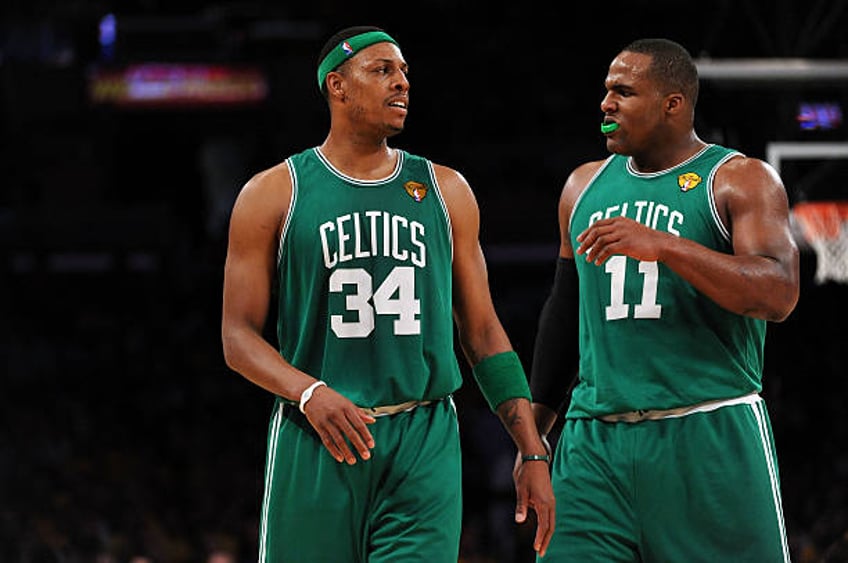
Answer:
[{"left": 568, "top": 145, "right": 766, "bottom": 418}]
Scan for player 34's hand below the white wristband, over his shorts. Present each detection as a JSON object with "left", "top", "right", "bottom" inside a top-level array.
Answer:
[{"left": 303, "top": 386, "right": 376, "bottom": 465}]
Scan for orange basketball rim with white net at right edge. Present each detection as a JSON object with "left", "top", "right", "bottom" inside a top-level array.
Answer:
[{"left": 792, "top": 200, "right": 848, "bottom": 284}]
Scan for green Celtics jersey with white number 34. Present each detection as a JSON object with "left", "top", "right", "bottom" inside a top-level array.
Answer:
[{"left": 277, "top": 148, "right": 462, "bottom": 407}]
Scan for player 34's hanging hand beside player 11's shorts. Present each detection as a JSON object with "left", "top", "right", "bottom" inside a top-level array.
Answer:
[{"left": 512, "top": 438, "right": 556, "bottom": 556}]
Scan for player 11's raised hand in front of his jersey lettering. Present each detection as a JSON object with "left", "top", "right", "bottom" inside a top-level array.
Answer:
[{"left": 576, "top": 217, "right": 673, "bottom": 266}]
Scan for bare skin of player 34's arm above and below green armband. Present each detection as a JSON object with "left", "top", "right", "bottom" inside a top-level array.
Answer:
[{"left": 435, "top": 165, "right": 555, "bottom": 554}]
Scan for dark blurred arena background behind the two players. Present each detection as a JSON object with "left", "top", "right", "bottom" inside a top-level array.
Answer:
[{"left": 0, "top": 0, "right": 848, "bottom": 563}]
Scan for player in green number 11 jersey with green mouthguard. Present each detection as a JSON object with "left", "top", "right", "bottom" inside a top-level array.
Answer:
[{"left": 531, "top": 39, "right": 799, "bottom": 563}]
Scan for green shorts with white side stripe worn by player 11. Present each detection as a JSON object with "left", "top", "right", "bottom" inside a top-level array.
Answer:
[{"left": 540, "top": 397, "right": 789, "bottom": 563}]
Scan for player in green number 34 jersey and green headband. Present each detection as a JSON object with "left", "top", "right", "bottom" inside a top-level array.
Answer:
[{"left": 222, "top": 27, "right": 554, "bottom": 563}]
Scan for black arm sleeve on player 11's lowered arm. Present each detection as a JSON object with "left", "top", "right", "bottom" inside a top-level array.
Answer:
[{"left": 530, "top": 258, "right": 580, "bottom": 414}]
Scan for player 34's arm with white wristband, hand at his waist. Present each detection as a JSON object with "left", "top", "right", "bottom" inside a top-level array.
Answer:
[{"left": 221, "top": 165, "right": 374, "bottom": 464}]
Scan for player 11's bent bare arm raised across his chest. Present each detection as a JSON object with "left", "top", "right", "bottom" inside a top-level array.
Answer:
[{"left": 577, "top": 158, "right": 800, "bottom": 321}]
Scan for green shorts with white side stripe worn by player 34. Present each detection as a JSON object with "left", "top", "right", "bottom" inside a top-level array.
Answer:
[{"left": 259, "top": 398, "right": 462, "bottom": 563}]
